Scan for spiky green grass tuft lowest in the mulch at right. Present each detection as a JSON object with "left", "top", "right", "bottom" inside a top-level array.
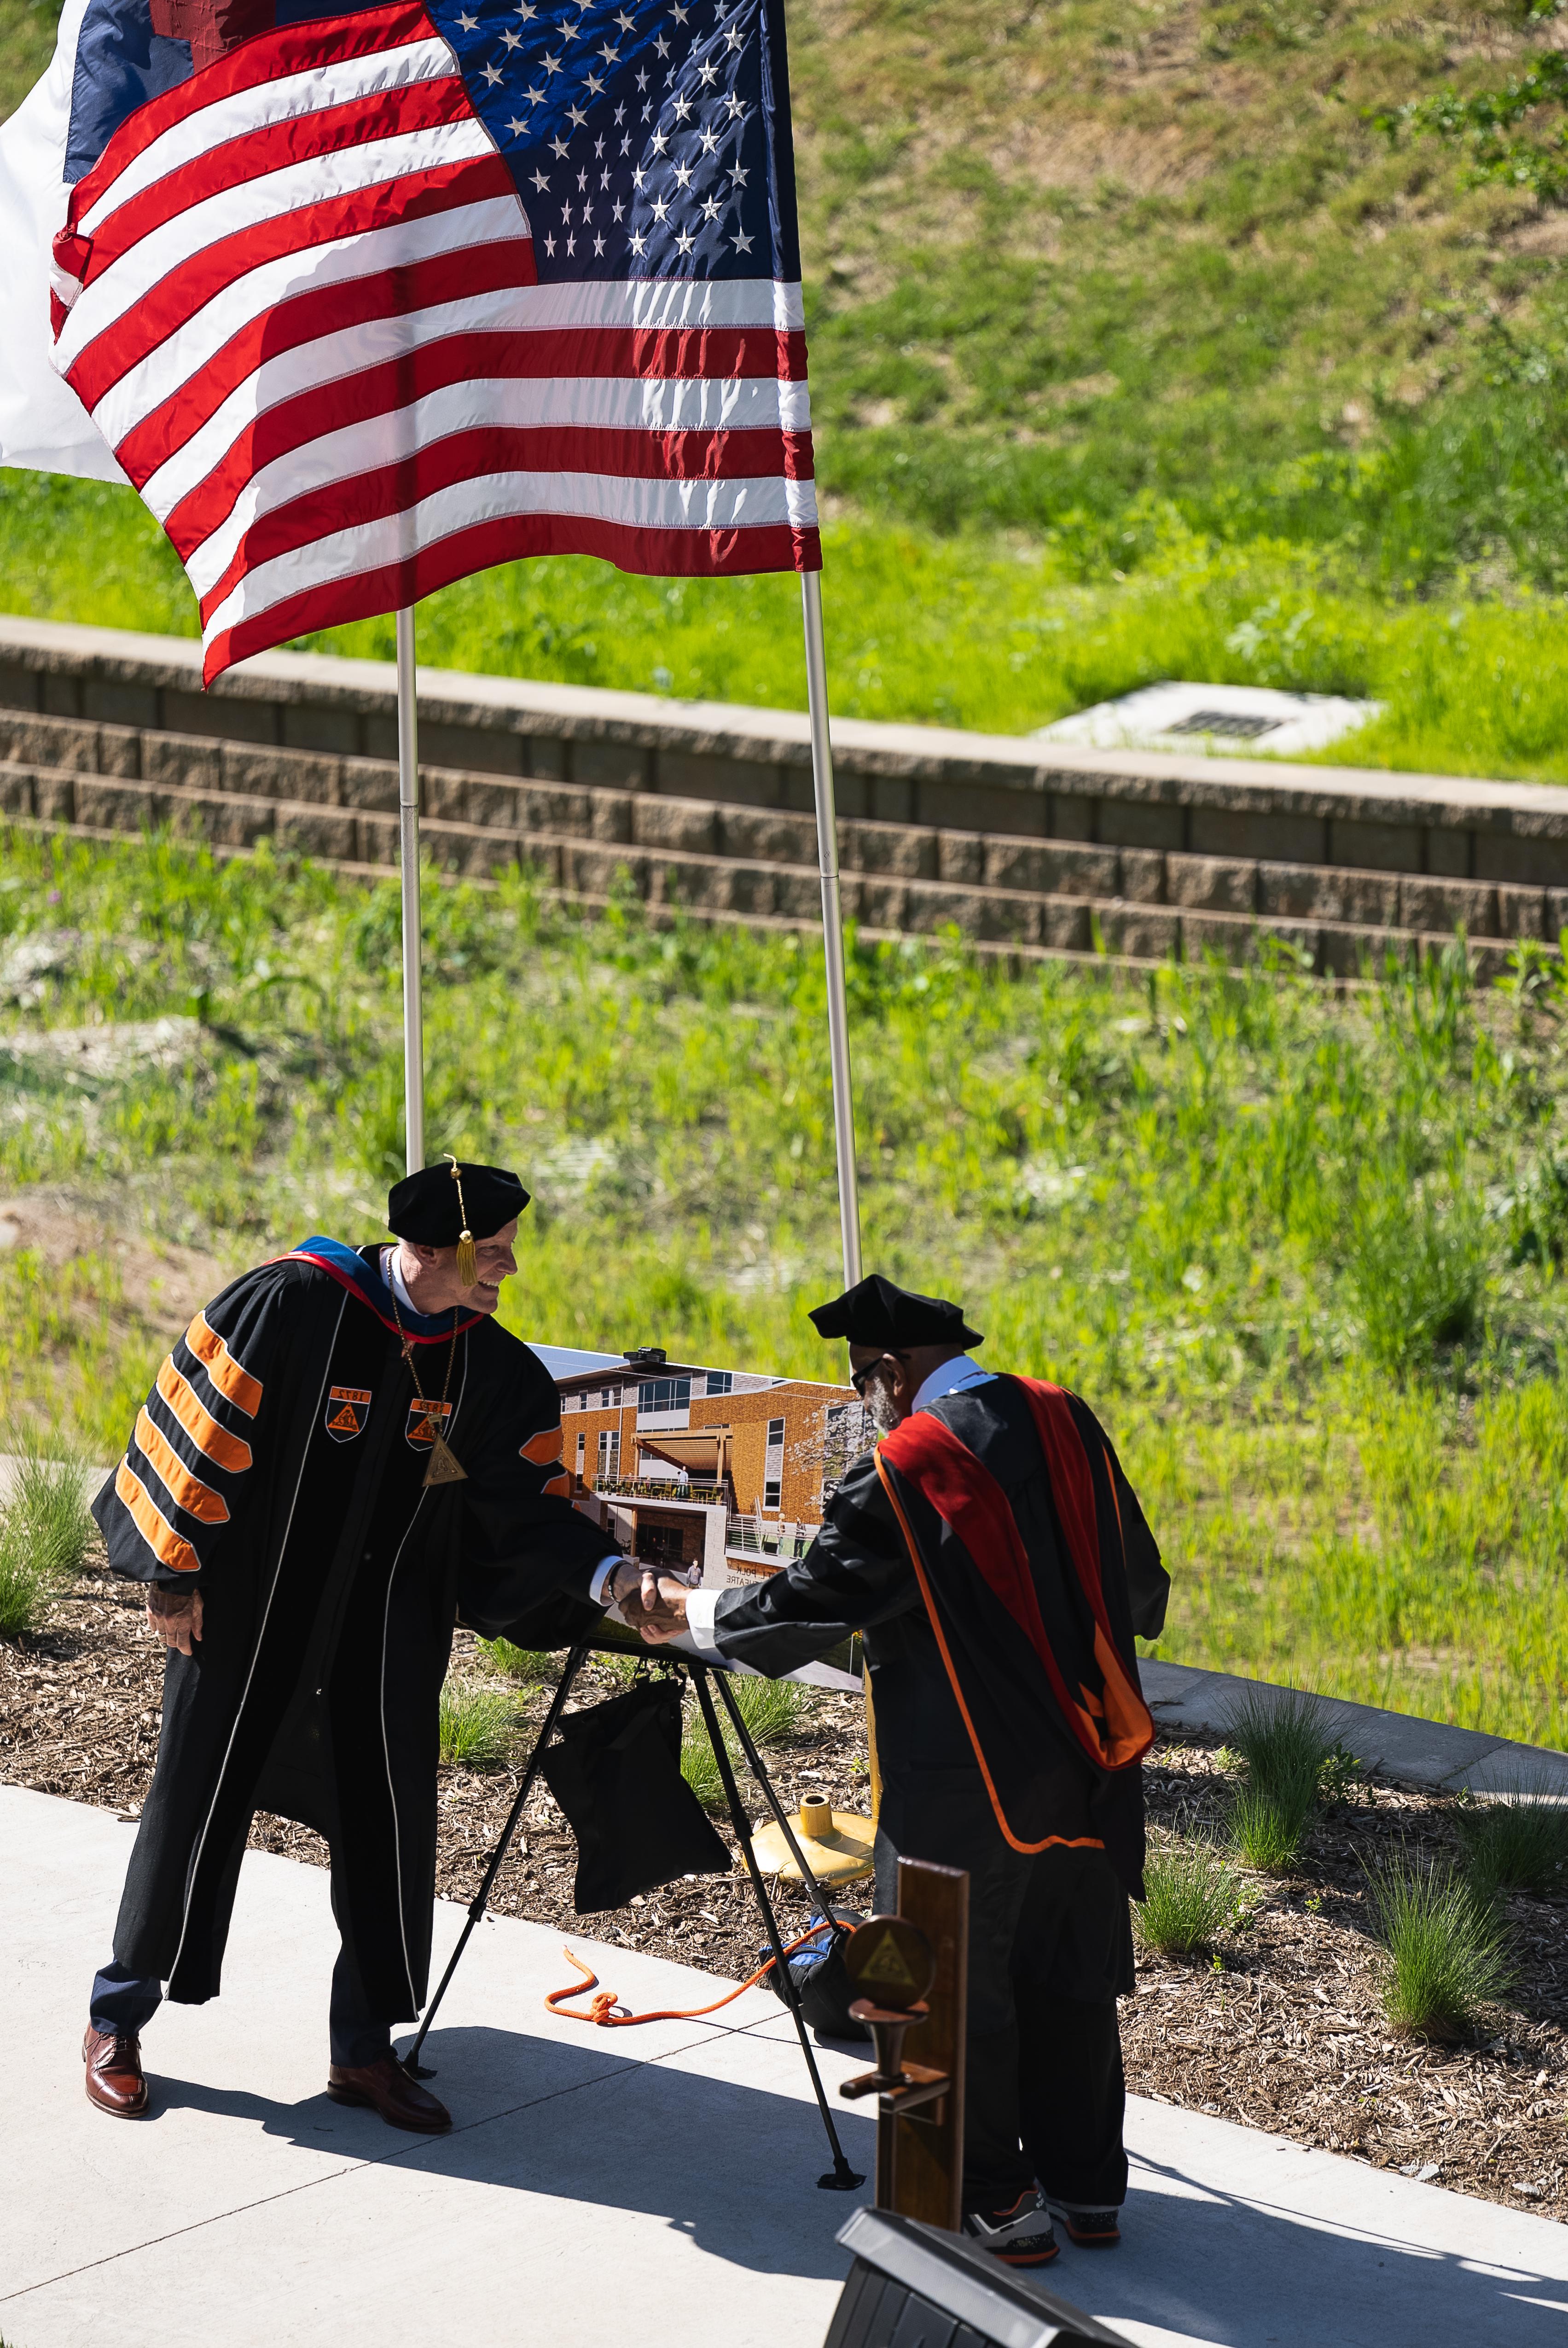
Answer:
[{"left": 1369, "top": 1855, "right": 1512, "bottom": 2043}]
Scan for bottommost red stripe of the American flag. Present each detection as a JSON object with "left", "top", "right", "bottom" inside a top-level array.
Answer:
[{"left": 204, "top": 512, "right": 822, "bottom": 679}]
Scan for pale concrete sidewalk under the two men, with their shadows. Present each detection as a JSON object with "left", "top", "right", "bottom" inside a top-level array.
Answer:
[{"left": 0, "top": 1787, "right": 1568, "bottom": 2348}]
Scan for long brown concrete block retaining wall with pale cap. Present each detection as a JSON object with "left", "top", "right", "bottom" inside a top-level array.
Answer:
[{"left": 0, "top": 620, "right": 1568, "bottom": 975}]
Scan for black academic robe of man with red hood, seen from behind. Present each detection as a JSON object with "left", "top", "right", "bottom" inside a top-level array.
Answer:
[{"left": 714, "top": 1378, "right": 1169, "bottom": 1895}]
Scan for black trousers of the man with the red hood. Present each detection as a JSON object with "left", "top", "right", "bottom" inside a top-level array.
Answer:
[{"left": 876, "top": 1768, "right": 1134, "bottom": 2209}]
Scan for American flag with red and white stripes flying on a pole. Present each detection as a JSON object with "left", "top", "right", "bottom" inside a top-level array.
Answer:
[{"left": 52, "top": 0, "right": 822, "bottom": 683}]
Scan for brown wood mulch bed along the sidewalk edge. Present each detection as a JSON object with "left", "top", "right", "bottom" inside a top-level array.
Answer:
[{"left": 0, "top": 1573, "right": 1568, "bottom": 2219}]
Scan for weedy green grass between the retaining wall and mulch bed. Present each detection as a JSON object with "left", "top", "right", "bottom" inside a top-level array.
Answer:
[{"left": 0, "top": 836, "right": 1568, "bottom": 1744}]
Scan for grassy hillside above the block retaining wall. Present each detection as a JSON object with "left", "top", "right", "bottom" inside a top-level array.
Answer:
[{"left": 0, "top": 0, "right": 1568, "bottom": 779}]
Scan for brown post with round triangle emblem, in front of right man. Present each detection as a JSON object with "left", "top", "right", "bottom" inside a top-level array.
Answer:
[{"left": 838, "top": 1860, "right": 970, "bottom": 2233}]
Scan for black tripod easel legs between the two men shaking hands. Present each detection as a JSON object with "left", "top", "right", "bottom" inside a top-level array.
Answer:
[{"left": 401, "top": 1641, "right": 866, "bottom": 2193}]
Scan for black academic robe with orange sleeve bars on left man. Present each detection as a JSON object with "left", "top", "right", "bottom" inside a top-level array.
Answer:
[{"left": 94, "top": 1240, "right": 605, "bottom": 2024}]
